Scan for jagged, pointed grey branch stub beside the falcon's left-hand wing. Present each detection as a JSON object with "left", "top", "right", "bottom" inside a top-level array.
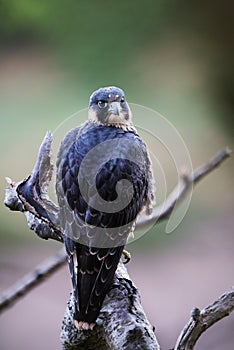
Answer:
[{"left": 4, "top": 131, "right": 63, "bottom": 242}]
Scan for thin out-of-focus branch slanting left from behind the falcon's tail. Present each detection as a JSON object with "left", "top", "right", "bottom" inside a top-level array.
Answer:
[{"left": 0, "top": 249, "right": 66, "bottom": 313}]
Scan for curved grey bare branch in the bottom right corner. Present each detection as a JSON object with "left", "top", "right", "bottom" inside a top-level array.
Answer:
[{"left": 174, "top": 287, "right": 234, "bottom": 350}]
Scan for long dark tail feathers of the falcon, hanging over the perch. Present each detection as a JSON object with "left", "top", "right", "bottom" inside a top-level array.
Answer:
[{"left": 72, "top": 245, "right": 124, "bottom": 329}]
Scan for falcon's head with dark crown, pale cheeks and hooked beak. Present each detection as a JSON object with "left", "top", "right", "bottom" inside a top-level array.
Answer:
[{"left": 89, "top": 86, "right": 131, "bottom": 129}]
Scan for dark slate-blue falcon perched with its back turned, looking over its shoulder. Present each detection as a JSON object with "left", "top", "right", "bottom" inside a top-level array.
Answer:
[{"left": 56, "top": 87, "right": 154, "bottom": 330}]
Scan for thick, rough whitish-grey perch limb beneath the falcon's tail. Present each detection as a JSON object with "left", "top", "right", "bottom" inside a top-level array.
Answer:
[{"left": 61, "top": 262, "right": 159, "bottom": 350}]
